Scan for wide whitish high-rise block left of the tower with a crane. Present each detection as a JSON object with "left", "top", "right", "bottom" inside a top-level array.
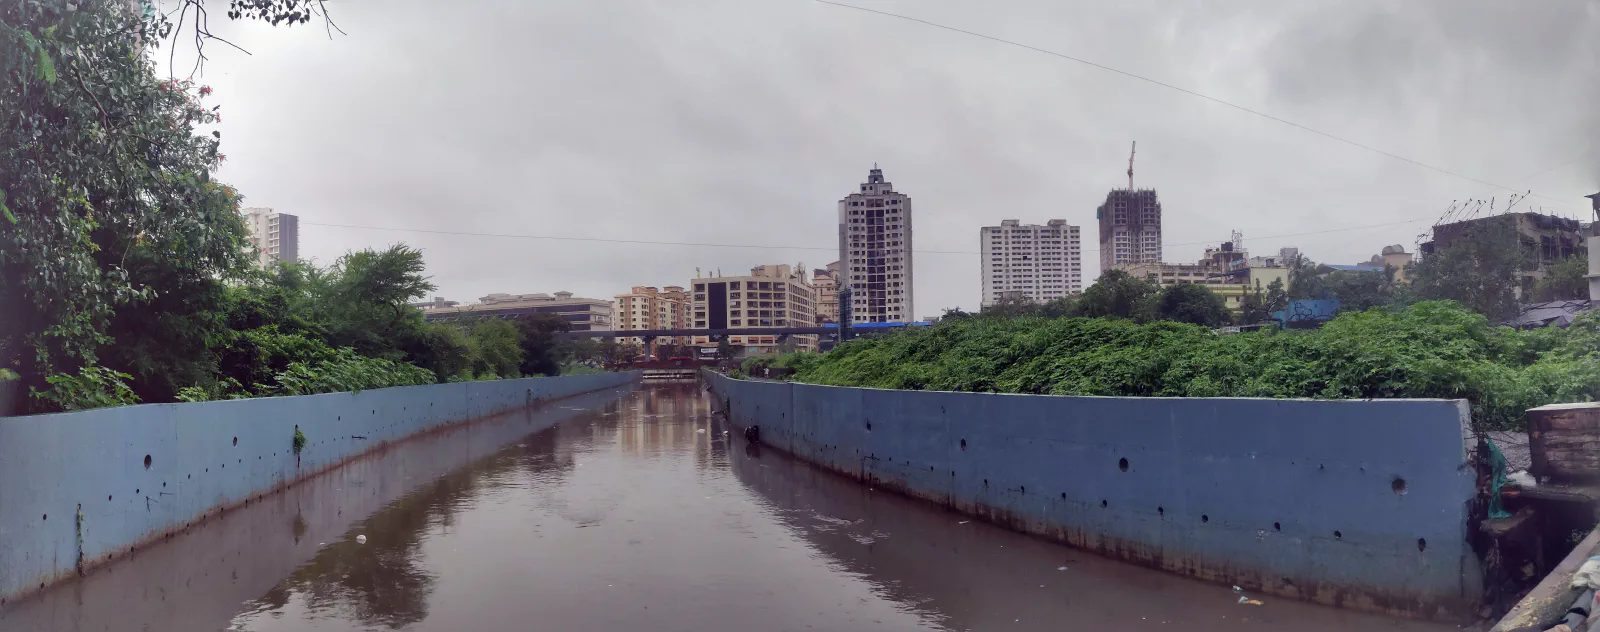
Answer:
[{"left": 978, "top": 219, "right": 1083, "bottom": 306}]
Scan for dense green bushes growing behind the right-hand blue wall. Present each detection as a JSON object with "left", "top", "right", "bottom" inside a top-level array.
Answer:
[{"left": 774, "top": 301, "right": 1600, "bottom": 427}]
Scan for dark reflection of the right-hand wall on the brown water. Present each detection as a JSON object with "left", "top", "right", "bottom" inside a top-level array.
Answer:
[{"left": 731, "top": 428, "right": 1454, "bottom": 630}]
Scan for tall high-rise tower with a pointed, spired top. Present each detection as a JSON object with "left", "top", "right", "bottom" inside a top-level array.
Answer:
[{"left": 838, "top": 165, "right": 914, "bottom": 323}]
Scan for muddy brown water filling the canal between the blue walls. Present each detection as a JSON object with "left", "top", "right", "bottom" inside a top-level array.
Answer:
[{"left": 0, "top": 384, "right": 1456, "bottom": 632}]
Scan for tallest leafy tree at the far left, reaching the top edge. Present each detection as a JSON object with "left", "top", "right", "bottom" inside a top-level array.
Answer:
[{"left": 0, "top": 0, "right": 248, "bottom": 406}]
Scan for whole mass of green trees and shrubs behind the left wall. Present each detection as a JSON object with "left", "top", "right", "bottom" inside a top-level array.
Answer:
[{"left": 0, "top": 0, "right": 605, "bottom": 414}]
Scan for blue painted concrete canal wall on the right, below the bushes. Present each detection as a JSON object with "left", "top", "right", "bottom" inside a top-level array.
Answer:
[{"left": 706, "top": 371, "right": 1482, "bottom": 621}]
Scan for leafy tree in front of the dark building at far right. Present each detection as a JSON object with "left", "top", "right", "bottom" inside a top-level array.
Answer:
[{"left": 1411, "top": 216, "right": 1533, "bottom": 322}]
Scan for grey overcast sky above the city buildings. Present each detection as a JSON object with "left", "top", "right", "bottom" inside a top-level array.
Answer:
[{"left": 172, "top": 0, "right": 1600, "bottom": 315}]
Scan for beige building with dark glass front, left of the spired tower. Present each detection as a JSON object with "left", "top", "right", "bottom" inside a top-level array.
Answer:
[{"left": 690, "top": 264, "right": 816, "bottom": 354}]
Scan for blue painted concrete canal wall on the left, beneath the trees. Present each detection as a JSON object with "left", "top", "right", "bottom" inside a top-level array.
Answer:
[{"left": 0, "top": 373, "right": 637, "bottom": 598}]
